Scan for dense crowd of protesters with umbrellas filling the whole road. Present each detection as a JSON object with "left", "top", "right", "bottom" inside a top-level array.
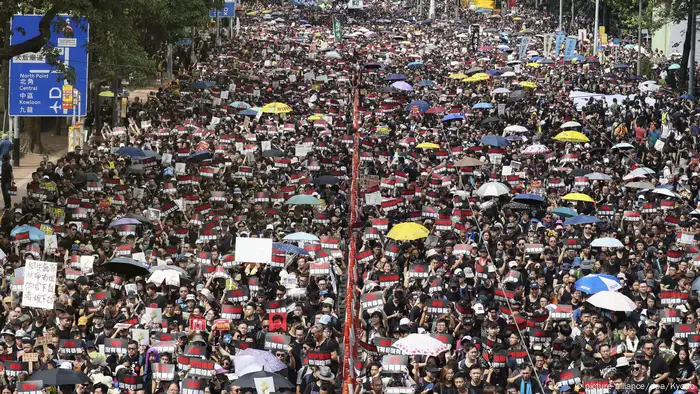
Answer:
[{"left": 0, "top": 3, "right": 700, "bottom": 394}]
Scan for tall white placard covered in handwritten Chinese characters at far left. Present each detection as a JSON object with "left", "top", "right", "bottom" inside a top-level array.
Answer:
[{"left": 22, "top": 260, "right": 56, "bottom": 309}]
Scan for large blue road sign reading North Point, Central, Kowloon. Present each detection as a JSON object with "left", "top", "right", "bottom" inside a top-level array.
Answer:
[{"left": 9, "top": 15, "right": 89, "bottom": 116}]
